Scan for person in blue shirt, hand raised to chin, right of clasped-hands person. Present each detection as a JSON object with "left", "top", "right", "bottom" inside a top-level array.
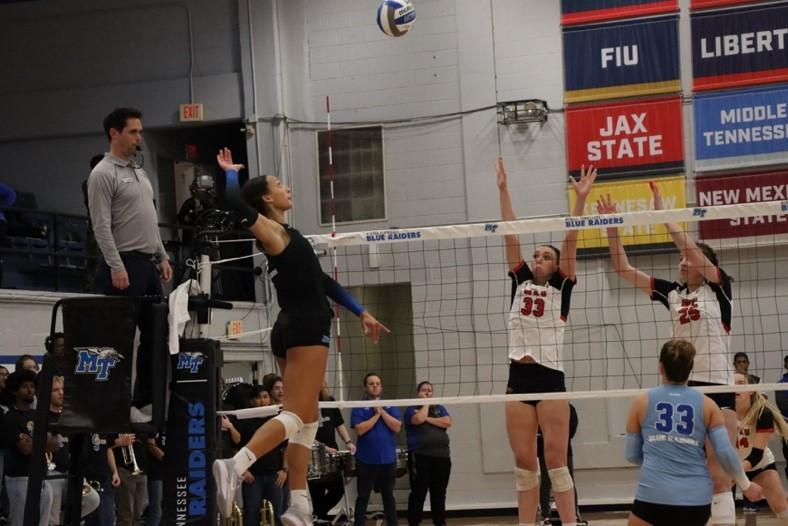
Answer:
[{"left": 403, "top": 381, "right": 452, "bottom": 526}]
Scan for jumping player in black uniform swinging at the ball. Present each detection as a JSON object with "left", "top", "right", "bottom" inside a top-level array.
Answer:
[{"left": 213, "top": 148, "right": 389, "bottom": 526}]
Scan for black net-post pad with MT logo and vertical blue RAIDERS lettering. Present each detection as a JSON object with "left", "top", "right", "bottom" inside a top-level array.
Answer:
[{"left": 163, "top": 340, "right": 221, "bottom": 526}]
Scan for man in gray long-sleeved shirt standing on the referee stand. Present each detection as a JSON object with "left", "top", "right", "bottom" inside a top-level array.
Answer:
[{"left": 88, "top": 108, "right": 172, "bottom": 420}]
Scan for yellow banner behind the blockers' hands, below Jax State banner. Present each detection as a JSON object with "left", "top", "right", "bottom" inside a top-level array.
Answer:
[{"left": 568, "top": 175, "right": 686, "bottom": 254}]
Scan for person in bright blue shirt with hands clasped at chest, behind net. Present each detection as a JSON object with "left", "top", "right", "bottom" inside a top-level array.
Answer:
[{"left": 350, "top": 373, "right": 402, "bottom": 526}]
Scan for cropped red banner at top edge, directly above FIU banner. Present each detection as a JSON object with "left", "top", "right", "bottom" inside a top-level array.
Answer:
[{"left": 561, "top": 0, "right": 679, "bottom": 26}]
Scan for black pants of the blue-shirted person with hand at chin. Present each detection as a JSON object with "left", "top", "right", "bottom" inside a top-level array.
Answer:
[{"left": 408, "top": 453, "right": 451, "bottom": 526}]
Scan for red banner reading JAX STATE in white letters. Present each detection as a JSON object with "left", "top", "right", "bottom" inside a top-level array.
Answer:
[{"left": 565, "top": 96, "right": 684, "bottom": 179}]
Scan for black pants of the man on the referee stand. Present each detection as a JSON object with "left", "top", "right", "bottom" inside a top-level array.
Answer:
[{"left": 95, "top": 253, "right": 162, "bottom": 407}]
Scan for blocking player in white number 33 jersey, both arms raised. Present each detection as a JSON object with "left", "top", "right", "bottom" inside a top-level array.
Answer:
[{"left": 496, "top": 157, "right": 596, "bottom": 526}]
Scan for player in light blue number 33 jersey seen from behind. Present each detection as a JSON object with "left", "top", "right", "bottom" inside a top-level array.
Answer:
[{"left": 625, "top": 340, "right": 762, "bottom": 526}]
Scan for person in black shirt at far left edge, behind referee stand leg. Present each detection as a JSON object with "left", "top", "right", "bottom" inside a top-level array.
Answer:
[{"left": 0, "top": 368, "right": 57, "bottom": 526}]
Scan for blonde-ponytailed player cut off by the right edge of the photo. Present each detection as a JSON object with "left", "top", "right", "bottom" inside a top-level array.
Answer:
[{"left": 736, "top": 373, "right": 788, "bottom": 525}]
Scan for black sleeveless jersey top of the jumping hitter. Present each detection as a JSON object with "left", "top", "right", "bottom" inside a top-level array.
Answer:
[{"left": 267, "top": 224, "right": 332, "bottom": 319}]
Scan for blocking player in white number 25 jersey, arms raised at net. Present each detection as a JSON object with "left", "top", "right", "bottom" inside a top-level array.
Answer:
[{"left": 597, "top": 182, "right": 736, "bottom": 526}]
